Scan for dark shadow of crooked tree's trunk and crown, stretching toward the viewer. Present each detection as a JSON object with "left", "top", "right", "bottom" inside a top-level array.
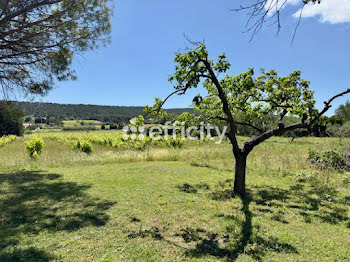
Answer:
[{"left": 177, "top": 190, "right": 297, "bottom": 261}]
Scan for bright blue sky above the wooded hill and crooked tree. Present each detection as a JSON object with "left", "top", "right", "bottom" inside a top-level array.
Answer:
[{"left": 36, "top": 0, "right": 350, "bottom": 114}]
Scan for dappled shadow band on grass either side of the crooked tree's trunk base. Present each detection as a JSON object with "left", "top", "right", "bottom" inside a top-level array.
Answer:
[{"left": 196, "top": 179, "right": 350, "bottom": 227}]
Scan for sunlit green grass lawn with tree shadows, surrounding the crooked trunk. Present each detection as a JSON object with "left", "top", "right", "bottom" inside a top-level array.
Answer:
[{"left": 0, "top": 134, "right": 350, "bottom": 261}]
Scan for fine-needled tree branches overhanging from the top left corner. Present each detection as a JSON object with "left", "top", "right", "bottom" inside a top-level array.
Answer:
[{"left": 0, "top": 0, "right": 112, "bottom": 94}]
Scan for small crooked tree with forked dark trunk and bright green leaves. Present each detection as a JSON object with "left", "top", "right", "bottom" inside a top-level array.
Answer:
[{"left": 145, "top": 43, "right": 350, "bottom": 196}]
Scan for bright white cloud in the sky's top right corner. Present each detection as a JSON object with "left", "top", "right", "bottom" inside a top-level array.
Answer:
[{"left": 291, "top": 0, "right": 350, "bottom": 24}]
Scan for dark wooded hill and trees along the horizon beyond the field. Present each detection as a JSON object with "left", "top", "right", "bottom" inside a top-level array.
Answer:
[{"left": 0, "top": 101, "right": 350, "bottom": 138}]
